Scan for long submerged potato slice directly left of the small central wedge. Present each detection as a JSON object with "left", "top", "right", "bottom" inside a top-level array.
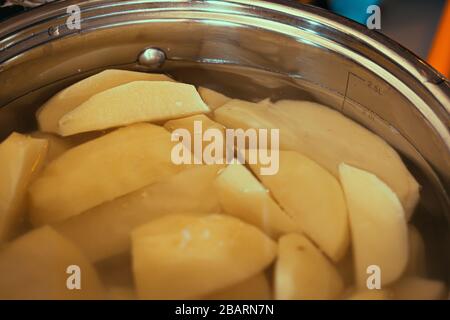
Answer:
[{"left": 55, "top": 165, "right": 223, "bottom": 261}]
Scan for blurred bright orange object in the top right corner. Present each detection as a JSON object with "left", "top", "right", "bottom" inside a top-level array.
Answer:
[{"left": 428, "top": 0, "right": 450, "bottom": 78}]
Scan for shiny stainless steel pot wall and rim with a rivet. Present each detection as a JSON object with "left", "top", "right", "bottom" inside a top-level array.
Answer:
[{"left": 0, "top": 0, "right": 450, "bottom": 284}]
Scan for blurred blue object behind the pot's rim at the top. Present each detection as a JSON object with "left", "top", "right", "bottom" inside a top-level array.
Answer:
[{"left": 328, "top": 0, "right": 381, "bottom": 24}]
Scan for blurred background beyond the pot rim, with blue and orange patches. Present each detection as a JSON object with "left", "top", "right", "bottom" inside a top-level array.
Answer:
[{"left": 0, "top": 0, "right": 450, "bottom": 77}]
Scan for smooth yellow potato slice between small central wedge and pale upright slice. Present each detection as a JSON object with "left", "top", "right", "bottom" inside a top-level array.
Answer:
[{"left": 250, "top": 151, "right": 349, "bottom": 261}]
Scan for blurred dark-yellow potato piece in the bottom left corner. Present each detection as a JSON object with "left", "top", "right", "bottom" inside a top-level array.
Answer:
[{"left": 0, "top": 226, "right": 105, "bottom": 299}]
